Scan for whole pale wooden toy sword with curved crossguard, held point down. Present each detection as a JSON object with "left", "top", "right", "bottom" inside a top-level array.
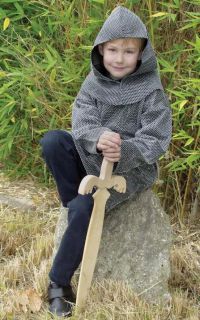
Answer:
[{"left": 76, "top": 158, "right": 126, "bottom": 310}]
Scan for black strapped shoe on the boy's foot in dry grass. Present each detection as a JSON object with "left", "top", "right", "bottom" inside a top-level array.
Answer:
[{"left": 48, "top": 283, "right": 76, "bottom": 317}]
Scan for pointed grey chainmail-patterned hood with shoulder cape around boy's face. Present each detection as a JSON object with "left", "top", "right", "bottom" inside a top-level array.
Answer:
[{"left": 77, "top": 6, "right": 162, "bottom": 105}]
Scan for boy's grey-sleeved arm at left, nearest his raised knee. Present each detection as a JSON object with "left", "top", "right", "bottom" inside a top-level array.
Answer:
[{"left": 72, "top": 96, "right": 112, "bottom": 154}]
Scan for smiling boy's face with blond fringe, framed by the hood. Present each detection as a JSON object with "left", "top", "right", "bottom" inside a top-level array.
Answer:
[{"left": 99, "top": 38, "right": 141, "bottom": 80}]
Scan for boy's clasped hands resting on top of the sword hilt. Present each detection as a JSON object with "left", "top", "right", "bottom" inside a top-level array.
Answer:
[{"left": 97, "top": 131, "right": 121, "bottom": 162}]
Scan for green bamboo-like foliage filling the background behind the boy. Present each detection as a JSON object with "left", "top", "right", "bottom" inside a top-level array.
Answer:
[{"left": 0, "top": 0, "right": 200, "bottom": 218}]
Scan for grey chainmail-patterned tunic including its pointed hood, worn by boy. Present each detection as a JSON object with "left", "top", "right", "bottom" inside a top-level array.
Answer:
[{"left": 72, "top": 6, "right": 172, "bottom": 211}]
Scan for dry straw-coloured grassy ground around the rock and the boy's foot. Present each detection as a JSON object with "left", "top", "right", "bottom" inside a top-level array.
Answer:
[{"left": 0, "top": 174, "right": 200, "bottom": 320}]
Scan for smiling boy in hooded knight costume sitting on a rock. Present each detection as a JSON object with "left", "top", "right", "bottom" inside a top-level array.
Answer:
[{"left": 41, "top": 6, "right": 171, "bottom": 317}]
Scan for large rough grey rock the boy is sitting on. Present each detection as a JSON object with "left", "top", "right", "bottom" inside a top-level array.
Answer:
[{"left": 55, "top": 190, "right": 171, "bottom": 303}]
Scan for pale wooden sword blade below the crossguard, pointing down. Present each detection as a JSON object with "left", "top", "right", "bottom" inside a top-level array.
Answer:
[{"left": 76, "top": 189, "right": 110, "bottom": 309}]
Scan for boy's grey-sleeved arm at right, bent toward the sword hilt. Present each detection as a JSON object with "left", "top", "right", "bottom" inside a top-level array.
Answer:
[{"left": 115, "top": 90, "right": 172, "bottom": 173}]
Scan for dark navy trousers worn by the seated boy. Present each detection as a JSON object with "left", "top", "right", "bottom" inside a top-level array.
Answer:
[{"left": 40, "top": 130, "right": 93, "bottom": 286}]
